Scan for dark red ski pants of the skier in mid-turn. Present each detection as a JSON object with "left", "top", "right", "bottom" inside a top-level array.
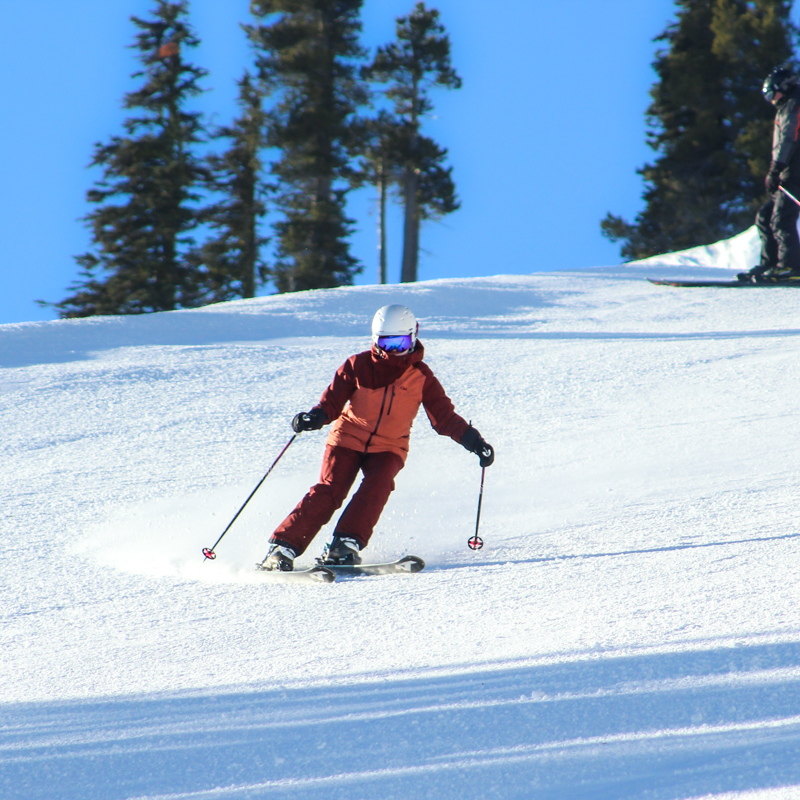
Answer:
[{"left": 270, "top": 446, "right": 403, "bottom": 555}]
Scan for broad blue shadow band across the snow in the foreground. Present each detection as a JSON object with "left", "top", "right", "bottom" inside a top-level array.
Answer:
[{"left": 0, "top": 642, "right": 800, "bottom": 800}]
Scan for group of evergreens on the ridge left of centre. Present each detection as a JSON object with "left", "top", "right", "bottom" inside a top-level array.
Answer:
[{"left": 53, "top": 0, "right": 461, "bottom": 317}]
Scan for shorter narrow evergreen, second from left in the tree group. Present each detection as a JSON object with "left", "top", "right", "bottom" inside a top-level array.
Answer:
[{"left": 190, "top": 72, "right": 268, "bottom": 303}]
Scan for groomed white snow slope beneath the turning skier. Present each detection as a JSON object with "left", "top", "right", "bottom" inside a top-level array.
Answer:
[{"left": 0, "top": 230, "right": 800, "bottom": 800}]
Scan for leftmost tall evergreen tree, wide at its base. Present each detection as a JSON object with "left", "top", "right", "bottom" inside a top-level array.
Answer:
[{"left": 55, "top": 0, "right": 206, "bottom": 317}]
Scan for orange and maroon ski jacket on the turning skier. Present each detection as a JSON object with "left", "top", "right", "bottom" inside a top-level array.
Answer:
[{"left": 318, "top": 340, "right": 469, "bottom": 463}]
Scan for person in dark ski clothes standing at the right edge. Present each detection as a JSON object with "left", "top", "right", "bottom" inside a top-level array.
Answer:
[{"left": 737, "top": 67, "right": 800, "bottom": 283}]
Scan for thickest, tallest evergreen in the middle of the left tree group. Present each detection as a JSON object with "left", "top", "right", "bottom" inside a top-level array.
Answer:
[{"left": 248, "top": 0, "right": 367, "bottom": 292}]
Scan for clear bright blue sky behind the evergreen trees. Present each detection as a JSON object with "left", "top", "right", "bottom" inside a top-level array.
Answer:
[{"left": 0, "top": 0, "right": 736, "bottom": 323}]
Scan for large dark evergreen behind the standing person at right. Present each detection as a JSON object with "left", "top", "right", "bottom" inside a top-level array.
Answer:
[{"left": 601, "top": 0, "right": 797, "bottom": 258}]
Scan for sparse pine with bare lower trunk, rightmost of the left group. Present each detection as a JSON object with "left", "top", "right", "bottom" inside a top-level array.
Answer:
[{"left": 364, "top": 2, "right": 461, "bottom": 282}]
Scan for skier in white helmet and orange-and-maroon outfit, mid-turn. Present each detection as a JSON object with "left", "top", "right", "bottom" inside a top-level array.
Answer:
[{"left": 262, "top": 305, "right": 494, "bottom": 571}]
